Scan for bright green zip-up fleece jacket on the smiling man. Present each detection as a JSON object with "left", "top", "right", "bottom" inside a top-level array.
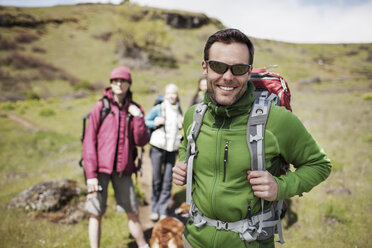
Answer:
[{"left": 179, "top": 82, "right": 331, "bottom": 248}]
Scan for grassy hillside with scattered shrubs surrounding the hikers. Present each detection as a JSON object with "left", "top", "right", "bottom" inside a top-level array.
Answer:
[{"left": 0, "top": 2, "right": 372, "bottom": 248}]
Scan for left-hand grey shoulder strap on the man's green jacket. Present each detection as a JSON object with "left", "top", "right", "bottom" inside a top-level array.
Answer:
[{"left": 185, "top": 102, "right": 207, "bottom": 205}]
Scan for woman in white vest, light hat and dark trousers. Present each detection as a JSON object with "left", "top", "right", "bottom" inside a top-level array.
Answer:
[{"left": 145, "top": 84, "right": 183, "bottom": 221}]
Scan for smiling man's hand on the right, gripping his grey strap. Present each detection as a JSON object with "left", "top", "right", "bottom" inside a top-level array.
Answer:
[{"left": 247, "top": 170, "right": 278, "bottom": 201}]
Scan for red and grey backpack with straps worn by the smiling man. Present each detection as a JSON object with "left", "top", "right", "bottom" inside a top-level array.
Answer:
[{"left": 185, "top": 69, "right": 292, "bottom": 244}]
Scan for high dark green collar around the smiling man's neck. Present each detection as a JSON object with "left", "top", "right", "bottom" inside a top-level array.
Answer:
[{"left": 204, "top": 81, "right": 255, "bottom": 118}]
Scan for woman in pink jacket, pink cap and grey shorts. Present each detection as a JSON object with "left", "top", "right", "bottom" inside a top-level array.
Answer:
[{"left": 83, "top": 66, "right": 149, "bottom": 247}]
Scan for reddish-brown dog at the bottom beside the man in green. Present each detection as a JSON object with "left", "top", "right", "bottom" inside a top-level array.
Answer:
[{"left": 150, "top": 203, "right": 190, "bottom": 248}]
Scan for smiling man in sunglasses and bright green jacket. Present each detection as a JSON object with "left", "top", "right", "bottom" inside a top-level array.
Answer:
[{"left": 173, "top": 29, "right": 331, "bottom": 248}]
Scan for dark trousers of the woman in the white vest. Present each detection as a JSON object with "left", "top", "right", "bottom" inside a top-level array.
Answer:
[{"left": 150, "top": 146, "right": 177, "bottom": 215}]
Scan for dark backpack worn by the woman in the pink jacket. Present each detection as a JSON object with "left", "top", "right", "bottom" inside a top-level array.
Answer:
[{"left": 79, "top": 96, "right": 144, "bottom": 183}]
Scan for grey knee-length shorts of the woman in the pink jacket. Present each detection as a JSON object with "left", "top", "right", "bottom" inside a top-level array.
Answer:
[{"left": 85, "top": 172, "right": 138, "bottom": 216}]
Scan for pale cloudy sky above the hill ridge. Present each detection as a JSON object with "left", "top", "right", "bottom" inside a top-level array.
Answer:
[{"left": 0, "top": 0, "right": 372, "bottom": 43}]
